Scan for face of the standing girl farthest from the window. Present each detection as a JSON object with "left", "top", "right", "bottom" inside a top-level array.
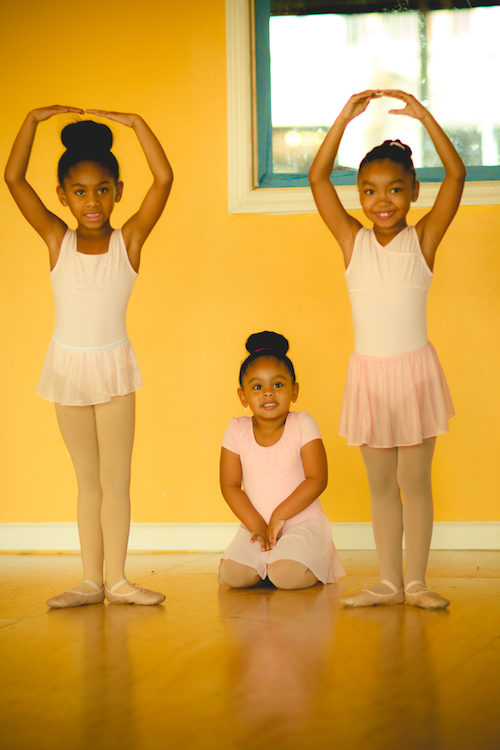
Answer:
[{"left": 57, "top": 161, "right": 123, "bottom": 229}]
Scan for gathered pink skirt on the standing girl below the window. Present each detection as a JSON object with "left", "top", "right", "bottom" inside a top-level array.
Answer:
[{"left": 339, "top": 343, "right": 455, "bottom": 448}]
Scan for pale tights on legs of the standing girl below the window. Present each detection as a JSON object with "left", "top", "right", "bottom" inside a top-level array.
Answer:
[{"left": 361, "top": 438, "right": 436, "bottom": 593}]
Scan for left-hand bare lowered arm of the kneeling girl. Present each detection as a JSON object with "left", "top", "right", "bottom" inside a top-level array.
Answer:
[{"left": 220, "top": 448, "right": 271, "bottom": 551}]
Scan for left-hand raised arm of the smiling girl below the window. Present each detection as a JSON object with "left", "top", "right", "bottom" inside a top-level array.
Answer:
[{"left": 309, "top": 91, "right": 382, "bottom": 267}]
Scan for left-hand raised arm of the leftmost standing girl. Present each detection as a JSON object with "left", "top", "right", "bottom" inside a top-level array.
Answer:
[{"left": 5, "top": 104, "right": 83, "bottom": 258}]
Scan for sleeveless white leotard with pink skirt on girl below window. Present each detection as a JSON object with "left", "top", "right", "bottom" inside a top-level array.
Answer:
[{"left": 339, "top": 227, "right": 454, "bottom": 448}]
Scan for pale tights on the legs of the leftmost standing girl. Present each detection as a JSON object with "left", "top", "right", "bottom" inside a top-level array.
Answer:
[{"left": 56, "top": 393, "right": 135, "bottom": 593}]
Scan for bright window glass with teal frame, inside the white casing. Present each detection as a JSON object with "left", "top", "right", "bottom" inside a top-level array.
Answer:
[{"left": 255, "top": 0, "right": 500, "bottom": 187}]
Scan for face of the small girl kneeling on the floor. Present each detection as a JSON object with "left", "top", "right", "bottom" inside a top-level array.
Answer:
[{"left": 238, "top": 357, "right": 299, "bottom": 420}]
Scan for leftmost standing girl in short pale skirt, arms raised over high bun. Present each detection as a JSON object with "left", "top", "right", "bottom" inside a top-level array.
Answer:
[{"left": 5, "top": 106, "right": 173, "bottom": 608}]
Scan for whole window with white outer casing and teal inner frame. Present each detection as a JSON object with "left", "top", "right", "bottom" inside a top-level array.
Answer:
[{"left": 226, "top": 0, "right": 500, "bottom": 213}]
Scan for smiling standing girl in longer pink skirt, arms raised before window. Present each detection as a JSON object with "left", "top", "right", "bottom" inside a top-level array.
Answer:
[{"left": 309, "top": 90, "right": 465, "bottom": 609}]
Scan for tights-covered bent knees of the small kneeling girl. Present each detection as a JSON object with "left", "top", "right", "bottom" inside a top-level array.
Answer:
[{"left": 220, "top": 560, "right": 318, "bottom": 590}]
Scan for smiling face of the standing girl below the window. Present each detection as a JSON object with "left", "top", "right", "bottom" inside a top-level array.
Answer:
[{"left": 358, "top": 159, "right": 419, "bottom": 231}]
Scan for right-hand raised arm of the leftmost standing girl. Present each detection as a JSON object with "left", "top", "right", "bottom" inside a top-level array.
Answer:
[{"left": 86, "top": 109, "right": 174, "bottom": 270}]
